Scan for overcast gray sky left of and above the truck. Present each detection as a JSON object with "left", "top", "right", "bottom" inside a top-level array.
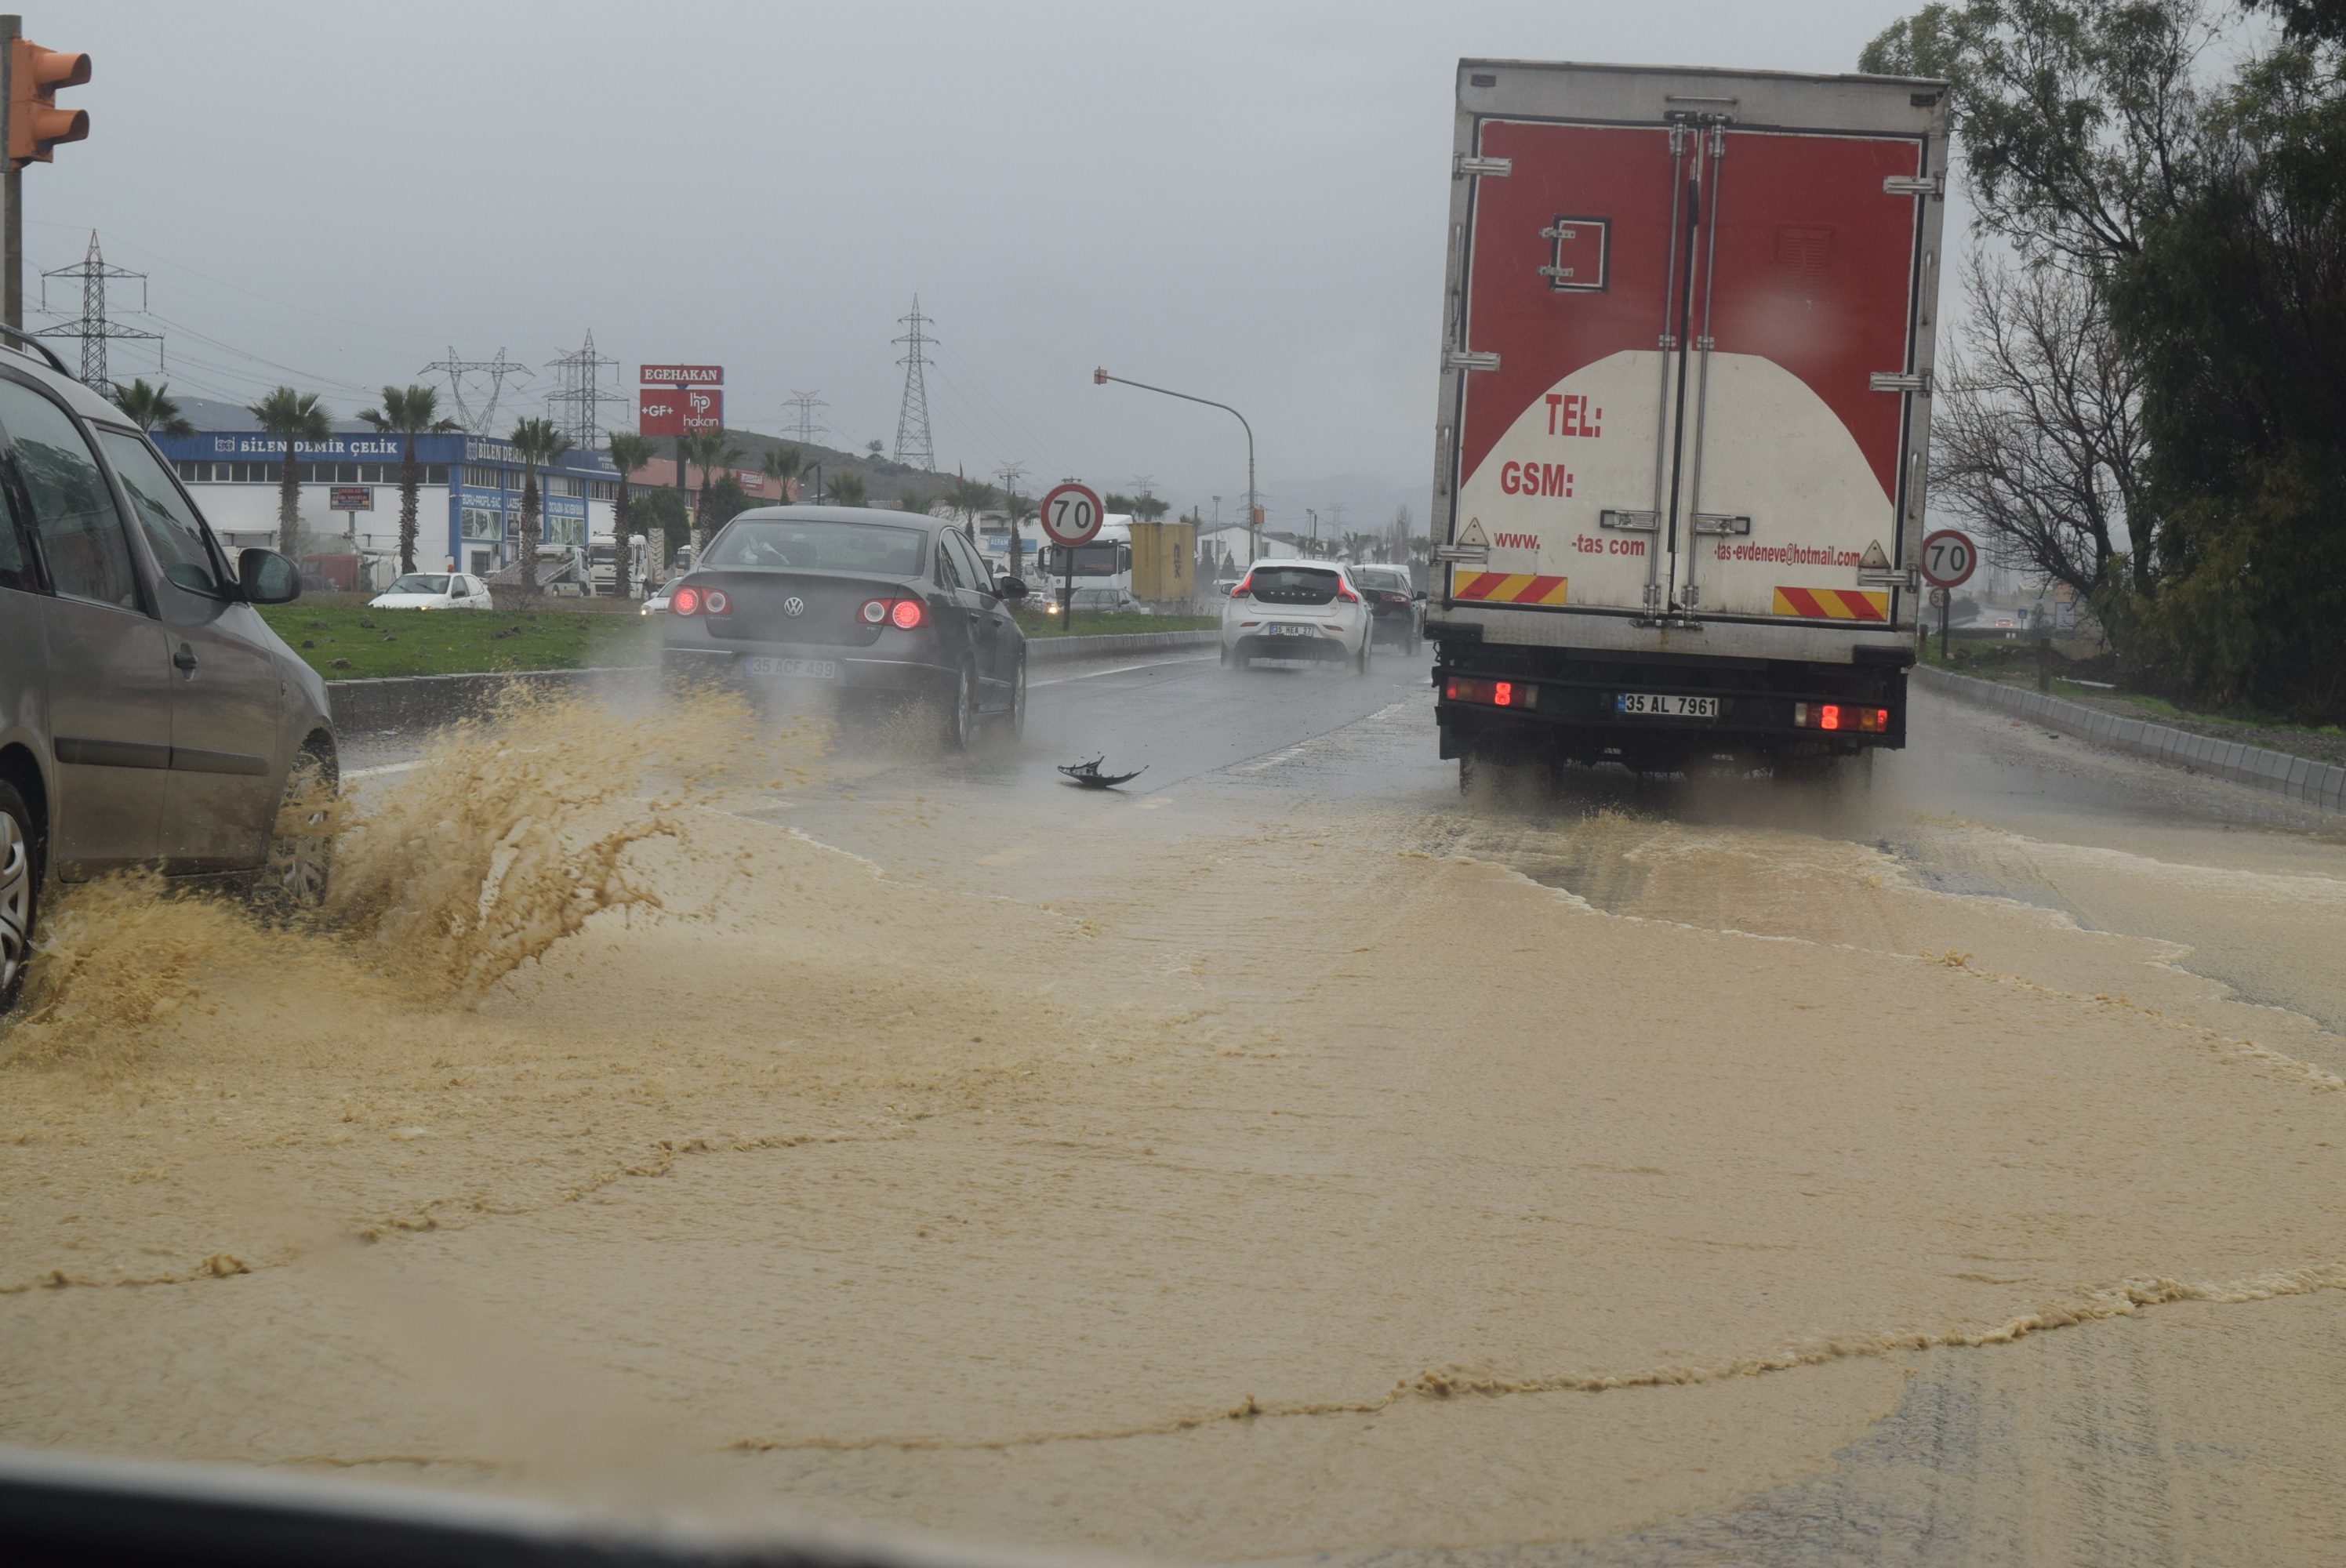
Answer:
[{"left": 41, "top": 0, "right": 1914, "bottom": 521}]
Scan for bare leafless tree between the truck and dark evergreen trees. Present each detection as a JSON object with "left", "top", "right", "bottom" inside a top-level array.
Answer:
[{"left": 1930, "top": 260, "right": 2152, "bottom": 596}]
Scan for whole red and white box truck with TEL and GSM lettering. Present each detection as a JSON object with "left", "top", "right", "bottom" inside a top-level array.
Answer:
[{"left": 1426, "top": 61, "right": 1947, "bottom": 768}]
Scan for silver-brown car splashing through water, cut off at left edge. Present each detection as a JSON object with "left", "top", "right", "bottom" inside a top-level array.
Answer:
[{"left": 0, "top": 328, "right": 336, "bottom": 1007}]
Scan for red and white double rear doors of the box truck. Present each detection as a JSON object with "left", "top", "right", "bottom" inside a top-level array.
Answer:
[{"left": 1445, "top": 66, "right": 1935, "bottom": 641}]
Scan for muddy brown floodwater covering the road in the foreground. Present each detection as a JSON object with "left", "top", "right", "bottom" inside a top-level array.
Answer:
[{"left": 0, "top": 704, "right": 2346, "bottom": 1561}]
